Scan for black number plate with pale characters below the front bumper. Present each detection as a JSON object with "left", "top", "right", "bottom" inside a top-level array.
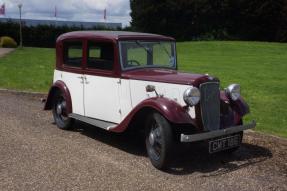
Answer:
[{"left": 209, "top": 135, "right": 240, "bottom": 153}]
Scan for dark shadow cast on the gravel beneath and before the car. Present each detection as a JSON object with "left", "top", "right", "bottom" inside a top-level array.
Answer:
[{"left": 71, "top": 122, "right": 272, "bottom": 177}]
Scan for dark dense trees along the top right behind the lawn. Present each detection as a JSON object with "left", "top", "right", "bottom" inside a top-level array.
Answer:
[{"left": 130, "top": 0, "right": 287, "bottom": 42}]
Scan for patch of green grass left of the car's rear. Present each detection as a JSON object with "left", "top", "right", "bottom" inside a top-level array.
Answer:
[{"left": 0, "top": 48, "right": 55, "bottom": 92}]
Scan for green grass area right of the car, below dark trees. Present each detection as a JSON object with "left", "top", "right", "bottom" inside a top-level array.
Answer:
[{"left": 177, "top": 42, "right": 287, "bottom": 137}]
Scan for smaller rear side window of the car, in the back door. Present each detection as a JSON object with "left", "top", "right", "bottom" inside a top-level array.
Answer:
[{"left": 64, "top": 41, "right": 83, "bottom": 67}]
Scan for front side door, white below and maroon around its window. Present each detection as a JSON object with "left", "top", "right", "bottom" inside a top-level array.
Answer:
[{"left": 84, "top": 41, "right": 121, "bottom": 123}]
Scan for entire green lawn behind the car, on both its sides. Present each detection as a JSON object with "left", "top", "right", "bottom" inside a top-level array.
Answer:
[{"left": 0, "top": 41, "right": 287, "bottom": 137}]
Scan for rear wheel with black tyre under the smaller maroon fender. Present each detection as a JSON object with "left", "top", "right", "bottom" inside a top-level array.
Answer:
[{"left": 52, "top": 91, "right": 74, "bottom": 130}]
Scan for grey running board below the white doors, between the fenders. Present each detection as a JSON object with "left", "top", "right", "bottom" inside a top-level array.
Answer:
[{"left": 69, "top": 113, "right": 118, "bottom": 131}]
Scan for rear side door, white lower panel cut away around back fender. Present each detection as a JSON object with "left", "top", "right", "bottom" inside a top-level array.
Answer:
[{"left": 60, "top": 40, "right": 85, "bottom": 115}]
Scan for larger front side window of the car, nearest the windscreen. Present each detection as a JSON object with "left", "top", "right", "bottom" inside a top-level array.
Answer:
[{"left": 87, "top": 42, "right": 114, "bottom": 70}]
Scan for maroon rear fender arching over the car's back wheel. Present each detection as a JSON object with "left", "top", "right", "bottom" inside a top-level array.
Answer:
[{"left": 44, "top": 80, "right": 72, "bottom": 114}]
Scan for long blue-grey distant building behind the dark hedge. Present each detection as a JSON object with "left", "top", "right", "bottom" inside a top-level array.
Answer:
[{"left": 0, "top": 18, "right": 122, "bottom": 29}]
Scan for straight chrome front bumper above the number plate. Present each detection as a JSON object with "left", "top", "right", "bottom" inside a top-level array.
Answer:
[{"left": 180, "top": 121, "right": 256, "bottom": 142}]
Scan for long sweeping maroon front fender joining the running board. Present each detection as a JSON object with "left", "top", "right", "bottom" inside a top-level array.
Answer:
[{"left": 111, "top": 97, "right": 197, "bottom": 132}]
